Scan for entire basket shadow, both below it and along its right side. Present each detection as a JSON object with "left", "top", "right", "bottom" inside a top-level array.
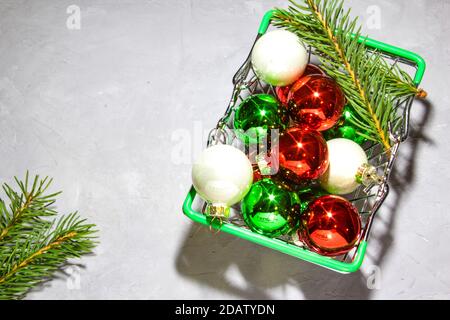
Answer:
[{"left": 175, "top": 101, "right": 433, "bottom": 299}]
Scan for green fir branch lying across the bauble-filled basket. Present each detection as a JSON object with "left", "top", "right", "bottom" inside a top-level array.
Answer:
[{"left": 273, "top": 0, "right": 424, "bottom": 150}]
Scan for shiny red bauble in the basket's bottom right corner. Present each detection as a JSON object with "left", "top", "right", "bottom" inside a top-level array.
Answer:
[{"left": 298, "top": 195, "right": 361, "bottom": 256}]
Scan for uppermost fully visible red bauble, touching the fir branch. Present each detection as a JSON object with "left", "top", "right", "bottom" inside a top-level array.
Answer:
[{"left": 288, "top": 74, "right": 345, "bottom": 131}]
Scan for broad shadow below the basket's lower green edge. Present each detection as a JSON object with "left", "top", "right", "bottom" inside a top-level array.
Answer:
[{"left": 176, "top": 224, "right": 369, "bottom": 300}]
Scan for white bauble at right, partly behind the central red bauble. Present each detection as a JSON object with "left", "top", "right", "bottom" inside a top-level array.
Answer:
[{"left": 320, "top": 138, "right": 368, "bottom": 194}]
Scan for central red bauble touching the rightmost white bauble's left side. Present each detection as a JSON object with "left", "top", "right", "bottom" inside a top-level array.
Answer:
[{"left": 278, "top": 127, "right": 328, "bottom": 182}]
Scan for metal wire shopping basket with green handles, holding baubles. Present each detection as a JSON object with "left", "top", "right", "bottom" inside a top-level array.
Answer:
[{"left": 183, "top": 11, "right": 425, "bottom": 273}]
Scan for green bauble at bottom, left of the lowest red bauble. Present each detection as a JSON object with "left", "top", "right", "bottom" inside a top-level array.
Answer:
[{"left": 241, "top": 179, "right": 300, "bottom": 237}]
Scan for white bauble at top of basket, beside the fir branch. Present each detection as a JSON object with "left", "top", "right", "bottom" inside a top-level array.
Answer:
[{"left": 252, "top": 30, "right": 308, "bottom": 86}]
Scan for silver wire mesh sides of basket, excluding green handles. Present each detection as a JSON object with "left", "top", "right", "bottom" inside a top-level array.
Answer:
[{"left": 206, "top": 36, "right": 420, "bottom": 262}]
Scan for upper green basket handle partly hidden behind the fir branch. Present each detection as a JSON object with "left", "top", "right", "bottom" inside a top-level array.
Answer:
[{"left": 258, "top": 10, "right": 426, "bottom": 86}]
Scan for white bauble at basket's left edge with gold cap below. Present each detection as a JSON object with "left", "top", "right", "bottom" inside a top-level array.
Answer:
[{"left": 192, "top": 144, "right": 253, "bottom": 207}]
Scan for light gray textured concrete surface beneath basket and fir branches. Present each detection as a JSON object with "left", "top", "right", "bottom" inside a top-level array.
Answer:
[{"left": 0, "top": 0, "right": 450, "bottom": 299}]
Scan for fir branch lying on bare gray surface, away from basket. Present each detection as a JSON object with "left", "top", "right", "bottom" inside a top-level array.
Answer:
[{"left": 0, "top": 173, "right": 96, "bottom": 300}]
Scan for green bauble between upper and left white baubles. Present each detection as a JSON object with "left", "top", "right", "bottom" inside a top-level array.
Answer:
[{"left": 234, "top": 94, "right": 288, "bottom": 144}]
